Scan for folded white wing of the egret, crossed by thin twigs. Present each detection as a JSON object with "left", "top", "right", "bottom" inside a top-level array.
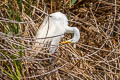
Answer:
[{"left": 36, "top": 17, "right": 65, "bottom": 53}]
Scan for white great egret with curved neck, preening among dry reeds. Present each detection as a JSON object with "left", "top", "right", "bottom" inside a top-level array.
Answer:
[{"left": 36, "top": 12, "right": 80, "bottom": 53}]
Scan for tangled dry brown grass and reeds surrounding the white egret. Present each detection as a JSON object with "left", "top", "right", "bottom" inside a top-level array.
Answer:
[{"left": 0, "top": 0, "right": 120, "bottom": 80}]
